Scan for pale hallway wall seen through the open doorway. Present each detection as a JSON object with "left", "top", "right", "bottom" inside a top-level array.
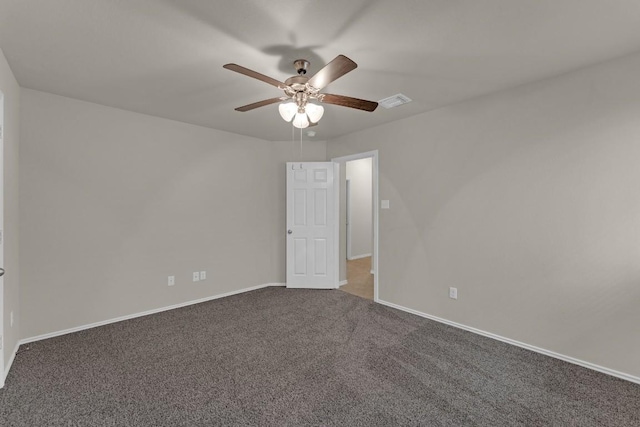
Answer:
[{"left": 345, "top": 158, "right": 373, "bottom": 258}]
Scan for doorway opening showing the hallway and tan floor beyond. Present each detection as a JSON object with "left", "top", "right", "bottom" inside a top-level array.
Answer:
[{"left": 331, "top": 150, "right": 379, "bottom": 302}]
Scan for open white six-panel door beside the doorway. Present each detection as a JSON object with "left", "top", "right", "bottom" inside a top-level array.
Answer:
[{"left": 287, "top": 162, "right": 338, "bottom": 289}]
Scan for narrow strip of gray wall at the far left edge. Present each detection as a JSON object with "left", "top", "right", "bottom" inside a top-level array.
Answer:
[{"left": 0, "top": 50, "right": 20, "bottom": 382}]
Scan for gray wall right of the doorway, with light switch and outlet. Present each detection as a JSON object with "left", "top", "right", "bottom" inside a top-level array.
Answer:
[{"left": 327, "top": 51, "right": 640, "bottom": 376}]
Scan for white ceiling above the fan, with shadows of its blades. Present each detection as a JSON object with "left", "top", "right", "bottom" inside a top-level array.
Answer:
[{"left": 0, "top": 0, "right": 640, "bottom": 140}]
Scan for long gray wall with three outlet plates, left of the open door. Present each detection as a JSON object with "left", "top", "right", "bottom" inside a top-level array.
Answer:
[{"left": 20, "top": 89, "right": 326, "bottom": 338}]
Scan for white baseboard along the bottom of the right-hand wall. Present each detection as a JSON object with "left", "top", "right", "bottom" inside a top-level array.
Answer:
[{"left": 376, "top": 299, "right": 640, "bottom": 384}]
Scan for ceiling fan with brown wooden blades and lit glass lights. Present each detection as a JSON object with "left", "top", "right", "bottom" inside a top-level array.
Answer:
[{"left": 223, "top": 55, "right": 378, "bottom": 128}]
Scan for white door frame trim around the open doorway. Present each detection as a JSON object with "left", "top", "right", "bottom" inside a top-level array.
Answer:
[{"left": 331, "top": 150, "right": 380, "bottom": 302}]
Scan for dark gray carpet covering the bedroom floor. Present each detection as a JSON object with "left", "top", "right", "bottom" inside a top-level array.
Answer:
[{"left": 0, "top": 288, "right": 640, "bottom": 426}]
